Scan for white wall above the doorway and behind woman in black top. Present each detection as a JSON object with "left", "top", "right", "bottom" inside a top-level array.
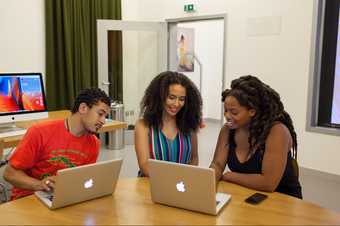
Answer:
[{"left": 123, "top": 0, "right": 340, "bottom": 175}]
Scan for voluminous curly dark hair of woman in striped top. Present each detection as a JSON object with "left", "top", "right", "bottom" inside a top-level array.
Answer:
[{"left": 140, "top": 71, "right": 202, "bottom": 134}]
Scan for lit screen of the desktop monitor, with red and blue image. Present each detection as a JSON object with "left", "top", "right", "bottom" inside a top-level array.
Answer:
[{"left": 0, "top": 74, "right": 46, "bottom": 115}]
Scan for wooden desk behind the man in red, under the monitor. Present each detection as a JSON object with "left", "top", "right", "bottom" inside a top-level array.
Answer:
[{"left": 0, "top": 110, "right": 127, "bottom": 159}]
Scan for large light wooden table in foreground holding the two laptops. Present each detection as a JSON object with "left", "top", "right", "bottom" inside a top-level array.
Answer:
[{"left": 0, "top": 178, "right": 340, "bottom": 225}]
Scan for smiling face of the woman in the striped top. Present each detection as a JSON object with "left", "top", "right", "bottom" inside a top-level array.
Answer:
[{"left": 164, "top": 84, "right": 186, "bottom": 117}]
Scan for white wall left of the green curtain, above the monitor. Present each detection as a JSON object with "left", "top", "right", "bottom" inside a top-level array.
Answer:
[{"left": 0, "top": 0, "right": 45, "bottom": 77}]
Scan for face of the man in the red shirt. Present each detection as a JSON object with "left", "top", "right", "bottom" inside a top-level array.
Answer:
[{"left": 79, "top": 101, "right": 110, "bottom": 133}]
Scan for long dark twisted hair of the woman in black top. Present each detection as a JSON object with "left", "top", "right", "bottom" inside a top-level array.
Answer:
[{"left": 222, "top": 75, "right": 297, "bottom": 159}]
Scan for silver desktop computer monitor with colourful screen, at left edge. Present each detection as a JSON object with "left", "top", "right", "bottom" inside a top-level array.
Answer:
[{"left": 0, "top": 73, "right": 48, "bottom": 132}]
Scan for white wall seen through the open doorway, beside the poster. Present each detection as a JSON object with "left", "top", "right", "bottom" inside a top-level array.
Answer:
[{"left": 178, "top": 20, "right": 224, "bottom": 120}]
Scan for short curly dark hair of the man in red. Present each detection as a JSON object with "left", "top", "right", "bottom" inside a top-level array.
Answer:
[{"left": 71, "top": 88, "right": 111, "bottom": 114}]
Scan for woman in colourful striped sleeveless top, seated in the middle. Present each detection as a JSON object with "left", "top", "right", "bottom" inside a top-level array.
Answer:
[{"left": 135, "top": 71, "right": 202, "bottom": 176}]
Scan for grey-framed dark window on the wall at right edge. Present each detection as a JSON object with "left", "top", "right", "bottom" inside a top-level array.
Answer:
[{"left": 307, "top": 0, "right": 340, "bottom": 135}]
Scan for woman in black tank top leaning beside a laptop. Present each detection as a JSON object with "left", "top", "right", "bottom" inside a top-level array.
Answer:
[{"left": 210, "top": 75, "right": 302, "bottom": 198}]
